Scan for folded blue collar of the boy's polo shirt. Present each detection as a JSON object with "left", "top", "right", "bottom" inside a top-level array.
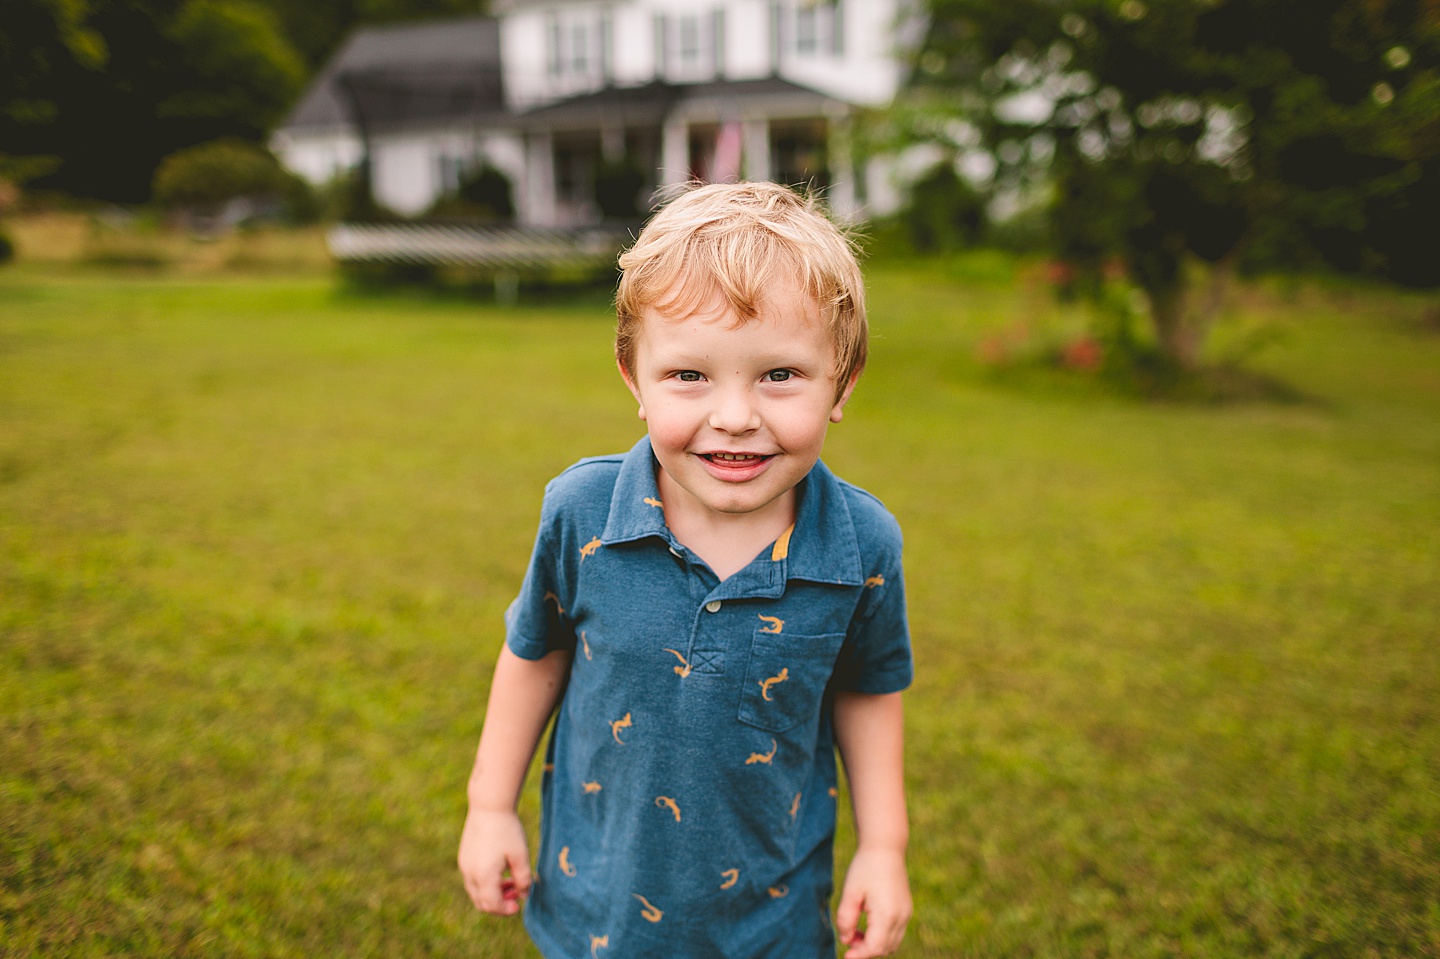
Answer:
[{"left": 600, "top": 435, "right": 864, "bottom": 586}]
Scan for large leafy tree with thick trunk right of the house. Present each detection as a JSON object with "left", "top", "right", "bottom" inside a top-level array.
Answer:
[{"left": 917, "top": 0, "right": 1440, "bottom": 367}]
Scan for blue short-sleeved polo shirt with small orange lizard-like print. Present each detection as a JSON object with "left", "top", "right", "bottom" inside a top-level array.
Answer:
[{"left": 505, "top": 438, "right": 912, "bottom": 959}]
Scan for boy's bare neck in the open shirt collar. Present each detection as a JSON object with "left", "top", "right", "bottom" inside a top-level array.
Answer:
[{"left": 655, "top": 467, "right": 798, "bottom": 580}]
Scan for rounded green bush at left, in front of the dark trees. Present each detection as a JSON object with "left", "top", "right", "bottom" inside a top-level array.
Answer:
[{"left": 153, "top": 138, "right": 289, "bottom": 213}]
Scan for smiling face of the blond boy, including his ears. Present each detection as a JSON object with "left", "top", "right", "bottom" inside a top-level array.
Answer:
[{"left": 621, "top": 276, "right": 854, "bottom": 523}]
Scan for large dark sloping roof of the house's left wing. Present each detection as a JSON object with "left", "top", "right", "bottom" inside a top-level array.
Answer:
[{"left": 281, "top": 17, "right": 505, "bottom": 130}]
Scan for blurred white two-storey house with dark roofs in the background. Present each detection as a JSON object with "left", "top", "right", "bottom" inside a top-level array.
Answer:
[{"left": 274, "top": 0, "right": 913, "bottom": 226}]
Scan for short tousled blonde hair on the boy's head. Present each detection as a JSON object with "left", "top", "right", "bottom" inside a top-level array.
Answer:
[{"left": 615, "top": 183, "right": 868, "bottom": 400}]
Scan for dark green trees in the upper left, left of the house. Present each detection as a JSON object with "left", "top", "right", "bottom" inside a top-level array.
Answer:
[{"left": 0, "top": 0, "right": 304, "bottom": 202}]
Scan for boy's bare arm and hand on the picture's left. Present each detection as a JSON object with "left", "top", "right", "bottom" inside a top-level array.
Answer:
[{"left": 458, "top": 647, "right": 570, "bottom": 916}]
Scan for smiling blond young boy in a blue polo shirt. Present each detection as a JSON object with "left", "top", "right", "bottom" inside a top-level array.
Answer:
[{"left": 459, "top": 183, "right": 912, "bottom": 959}]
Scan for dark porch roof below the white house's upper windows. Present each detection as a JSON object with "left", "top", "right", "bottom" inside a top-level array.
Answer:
[{"left": 520, "top": 76, "right": 831, "bottom": 128}]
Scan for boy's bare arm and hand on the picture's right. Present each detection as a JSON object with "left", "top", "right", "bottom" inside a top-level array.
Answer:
[{"left": 835, "top": 691, "right": 910, "bottom": 959}]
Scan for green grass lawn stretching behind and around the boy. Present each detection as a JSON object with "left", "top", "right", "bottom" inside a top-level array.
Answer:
[{"left": 0, "top": 258, "right": 1440, "bottom": 959}]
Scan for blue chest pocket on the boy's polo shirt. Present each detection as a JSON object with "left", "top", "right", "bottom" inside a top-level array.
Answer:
[{"left": 740, "top": 629, "right": 845, "bottom": 733}]
